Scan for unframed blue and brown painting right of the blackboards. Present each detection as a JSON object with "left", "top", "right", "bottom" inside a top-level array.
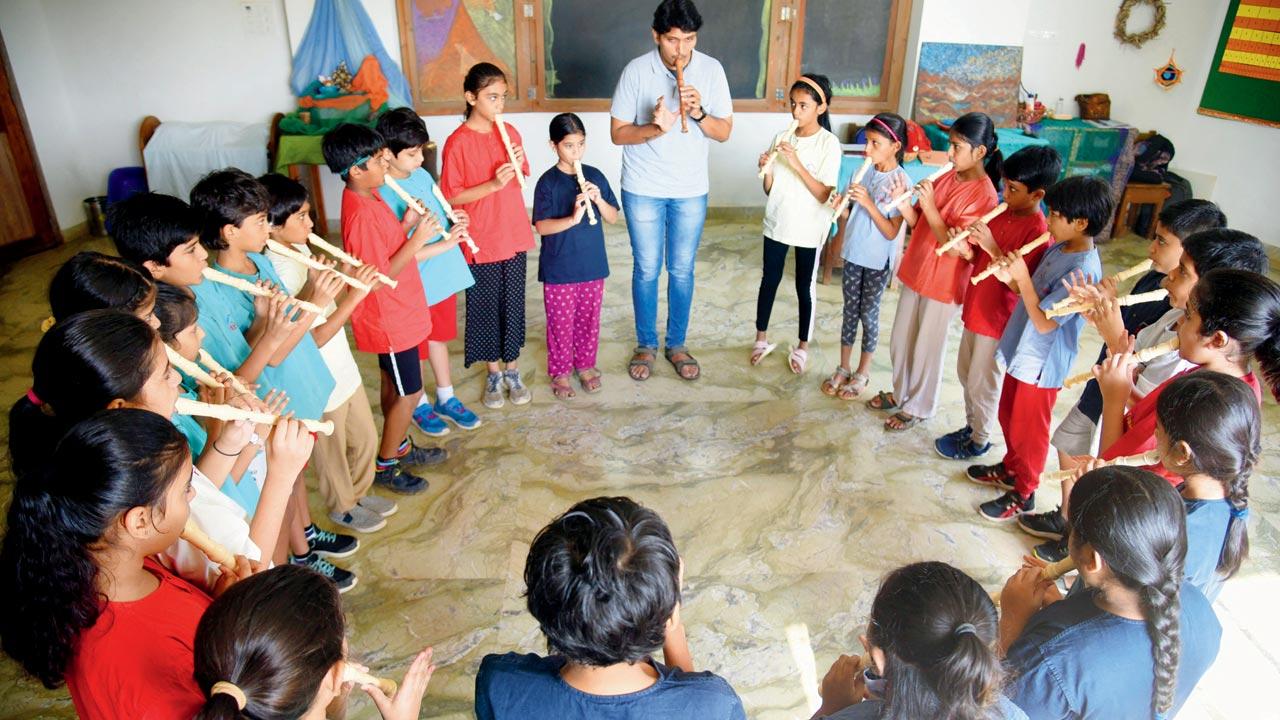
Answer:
[{"left": 913, "top": 42, "right": 1023, "bottom": 128}]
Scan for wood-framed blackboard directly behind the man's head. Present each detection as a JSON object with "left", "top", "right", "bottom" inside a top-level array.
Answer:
[{"left": 543, "top": 0, "right": 768, "bottom": 99}]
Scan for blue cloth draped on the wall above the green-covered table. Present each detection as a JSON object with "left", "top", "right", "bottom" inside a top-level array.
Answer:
[{"left": 289, "top": 0, "right": 412, "bottom": 108}]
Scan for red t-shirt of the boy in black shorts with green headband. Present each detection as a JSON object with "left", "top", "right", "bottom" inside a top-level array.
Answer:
[{"left": 342, "top": 188, "right": 431, "bottom": 354}]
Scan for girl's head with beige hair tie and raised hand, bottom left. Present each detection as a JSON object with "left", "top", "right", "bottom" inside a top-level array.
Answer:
[{"left": 186, "top": 565, "right": 435, "bottom": 720}]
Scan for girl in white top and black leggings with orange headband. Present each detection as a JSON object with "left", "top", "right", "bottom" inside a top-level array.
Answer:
[{"left": 751, "top": 73, "right": 840, "bottom": 373}]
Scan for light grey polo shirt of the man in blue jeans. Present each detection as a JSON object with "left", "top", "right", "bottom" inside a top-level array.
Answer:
[{"left": 609, "top": 47, "right": 733, "bottom": 197}]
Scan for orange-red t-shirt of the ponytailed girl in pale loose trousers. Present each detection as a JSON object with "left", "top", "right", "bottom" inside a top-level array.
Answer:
[{"left": 897, "top": 170, "right": 997, "bottom": 305}]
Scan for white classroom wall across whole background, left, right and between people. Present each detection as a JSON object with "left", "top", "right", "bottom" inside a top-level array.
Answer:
[{"left": 0, "top": 0, "right": 1280, "bottom": 243}]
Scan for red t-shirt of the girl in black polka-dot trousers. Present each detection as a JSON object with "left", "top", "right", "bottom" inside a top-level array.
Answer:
[{"left": 440, "top": 123, "right": 534, "bottom": 264}]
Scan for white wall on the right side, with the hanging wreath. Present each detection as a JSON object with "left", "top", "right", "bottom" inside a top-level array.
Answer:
[{"left": 902, "top": 0, "right": 1280, "bottom": 245}]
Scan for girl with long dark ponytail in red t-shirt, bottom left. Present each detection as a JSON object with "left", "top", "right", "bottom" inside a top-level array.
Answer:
[{"left": 0, "top": 409, "right": 234, "bottom": 719}]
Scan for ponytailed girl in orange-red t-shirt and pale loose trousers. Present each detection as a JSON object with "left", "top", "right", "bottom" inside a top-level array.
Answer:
[{"left": 867, "top": 113, "right": 1002, "bottom": 430}]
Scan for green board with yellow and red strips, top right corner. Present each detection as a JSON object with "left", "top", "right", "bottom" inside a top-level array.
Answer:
[{"left": 1199, "top": 0, "right": 1280, "bottom": 127}]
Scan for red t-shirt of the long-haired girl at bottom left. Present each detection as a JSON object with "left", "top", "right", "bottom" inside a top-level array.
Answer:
[{"left": 67, "top": 557, "right": 210, "bottom": 720}]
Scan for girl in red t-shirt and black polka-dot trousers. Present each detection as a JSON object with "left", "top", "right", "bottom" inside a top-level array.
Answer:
[{"left": 440, "top": 63, "right": 534, "bottom": 409}]
